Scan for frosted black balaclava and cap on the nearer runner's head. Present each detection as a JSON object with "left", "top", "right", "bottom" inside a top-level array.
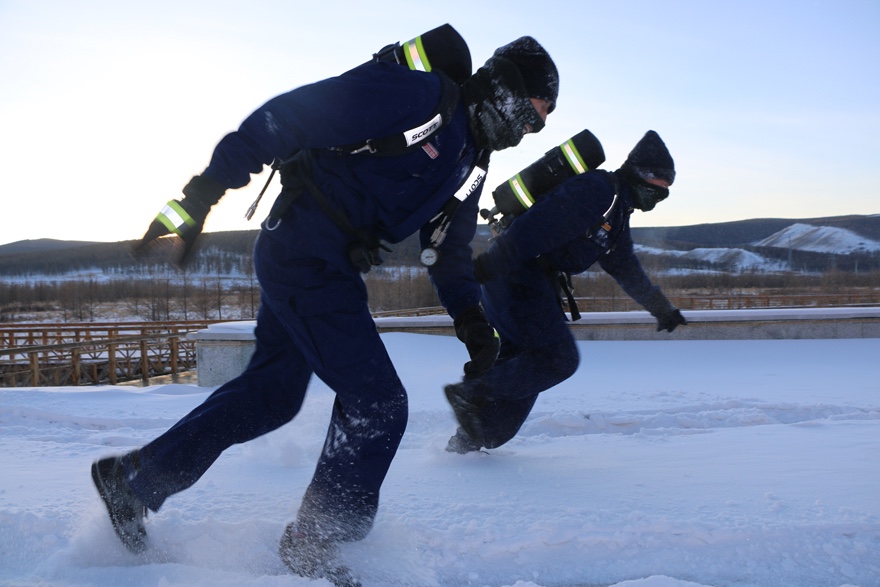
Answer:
[{"left": 462, "top": 37, "right": 559, "bottom": 151}]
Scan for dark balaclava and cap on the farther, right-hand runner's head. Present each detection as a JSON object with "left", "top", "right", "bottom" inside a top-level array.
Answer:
[{"left": 619, "top": 130, "right": 675, "bottom": 212}]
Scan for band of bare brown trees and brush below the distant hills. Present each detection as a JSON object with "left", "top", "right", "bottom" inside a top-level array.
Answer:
[{"left": 0, "top": 266, "right": 880, "bottom": 322}]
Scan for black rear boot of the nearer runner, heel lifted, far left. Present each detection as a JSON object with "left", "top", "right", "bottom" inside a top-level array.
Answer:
[{"left": 92, "top": 457, "right": 147, "bottom": 554}]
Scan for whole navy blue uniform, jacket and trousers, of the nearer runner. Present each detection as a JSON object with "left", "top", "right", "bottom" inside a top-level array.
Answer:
[{"left": 124, "top": 63, "right": 481, "bottom": 541}]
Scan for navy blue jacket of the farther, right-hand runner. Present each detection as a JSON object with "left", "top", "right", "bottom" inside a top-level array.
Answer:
[{"left": 488, "top": 171, "right": 658, "bottom": 306}]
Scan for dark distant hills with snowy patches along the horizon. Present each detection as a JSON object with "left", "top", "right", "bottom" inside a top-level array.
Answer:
[{"left": 0, "top": 214, "right": 880, "bottom": 277}]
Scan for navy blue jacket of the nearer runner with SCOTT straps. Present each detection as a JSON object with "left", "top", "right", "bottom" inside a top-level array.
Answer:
[{"left": 198, "top": 62, "right": 482, "bottom": 317}]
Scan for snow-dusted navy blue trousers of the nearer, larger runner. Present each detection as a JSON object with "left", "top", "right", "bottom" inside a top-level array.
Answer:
[{"left": 126, "top": 235, "right": 407, "bottom": 541}]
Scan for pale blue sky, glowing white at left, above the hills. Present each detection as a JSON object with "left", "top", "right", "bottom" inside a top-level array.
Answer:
[{"left": 0, "top": 0, "right": 880, "bottom": 244}]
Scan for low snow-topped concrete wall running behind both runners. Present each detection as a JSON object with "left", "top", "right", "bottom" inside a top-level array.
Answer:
[{"left": 188, "top": 307, "right": 880, "bottom": 387}]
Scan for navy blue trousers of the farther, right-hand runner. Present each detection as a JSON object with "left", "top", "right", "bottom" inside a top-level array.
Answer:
[{"left": 472, "top": 261, "right": 580, "bottom": 448}]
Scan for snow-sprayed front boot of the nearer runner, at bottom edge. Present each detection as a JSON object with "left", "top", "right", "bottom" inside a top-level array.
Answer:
[{"left": 278, "top": 523, "right": 361, "bottom": 587}]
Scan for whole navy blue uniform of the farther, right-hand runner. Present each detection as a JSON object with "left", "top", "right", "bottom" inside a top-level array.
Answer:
[{"left": 473, "top": 171, "right": 662, "bottom": 448}]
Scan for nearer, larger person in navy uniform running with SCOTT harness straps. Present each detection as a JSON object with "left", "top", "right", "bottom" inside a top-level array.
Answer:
[{"left": 92, "top": 25, "right": 558, "bottom": 586}]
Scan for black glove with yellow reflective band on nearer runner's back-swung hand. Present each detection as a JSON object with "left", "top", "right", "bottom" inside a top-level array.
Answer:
[{"left": 134, "top": 175, "right": 226, "bottom": 266}]
